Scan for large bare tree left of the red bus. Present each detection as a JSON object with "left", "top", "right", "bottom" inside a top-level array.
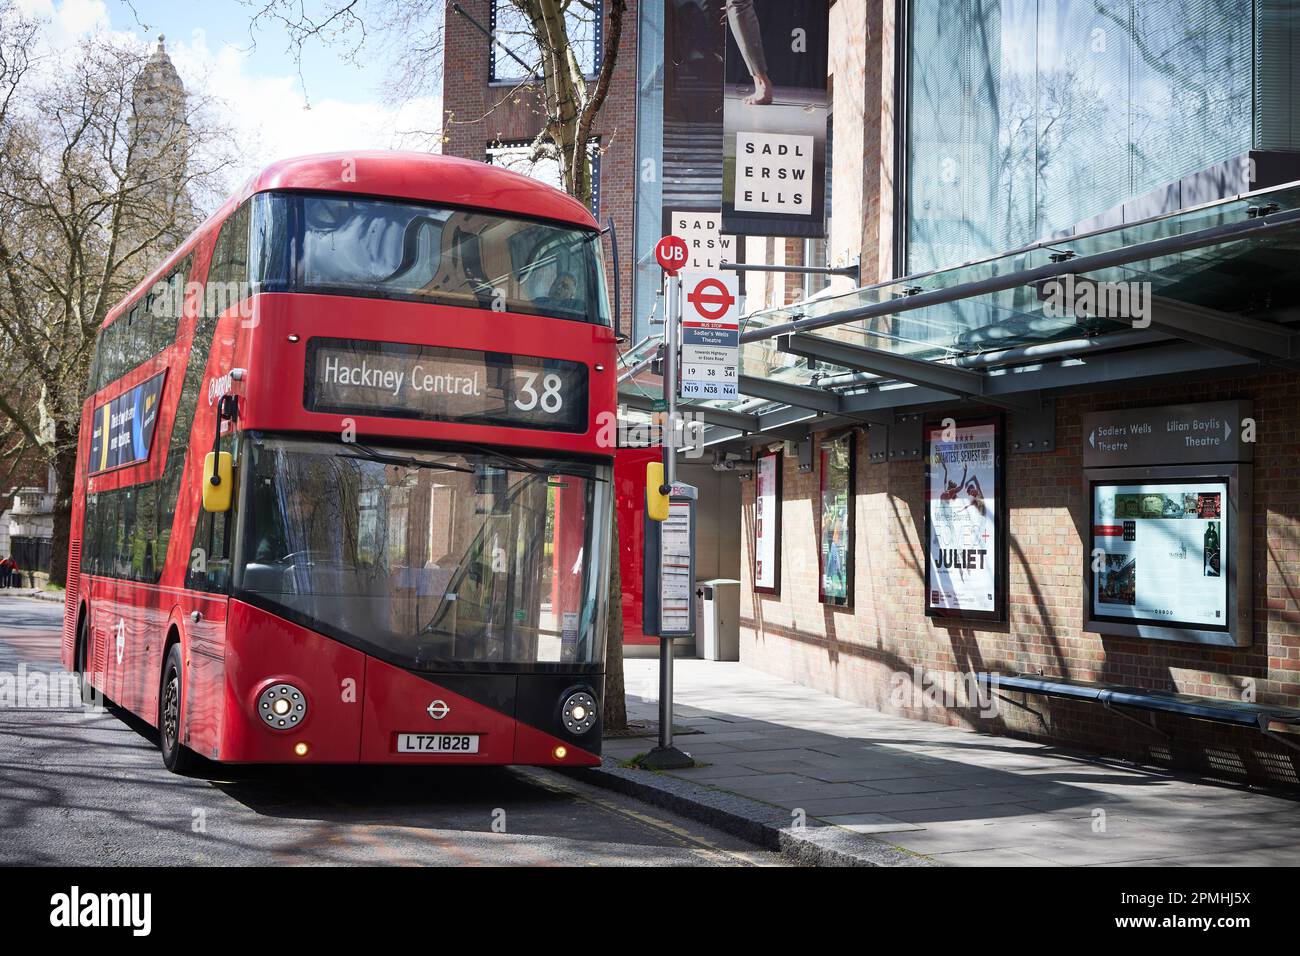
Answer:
[{"left": 0, "top": 13, "right": 233, "bottom": 583}]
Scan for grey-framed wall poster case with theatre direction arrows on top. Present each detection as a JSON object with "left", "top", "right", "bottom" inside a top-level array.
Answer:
[{"left": 1083, "top": 402, "right": 1253, "bottom": 646}]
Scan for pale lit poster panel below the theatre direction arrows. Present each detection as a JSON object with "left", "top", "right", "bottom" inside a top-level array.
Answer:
[{"left": 1092, "top": 480, "right": 1231, "bottom": 631}]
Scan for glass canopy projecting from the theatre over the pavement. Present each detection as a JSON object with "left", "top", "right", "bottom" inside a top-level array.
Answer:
[{"left": 619, "top": 183, "right": 1300, "bottom": 429}]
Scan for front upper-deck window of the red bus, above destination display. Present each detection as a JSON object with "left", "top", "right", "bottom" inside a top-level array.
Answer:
[{"left": 262, "top": 194, "right": 610, "bottom": 325}]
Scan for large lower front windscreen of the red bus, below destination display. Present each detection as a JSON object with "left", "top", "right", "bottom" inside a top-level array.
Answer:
[{"left": 235, "top": 436, "right": 610, "bottom": 670}]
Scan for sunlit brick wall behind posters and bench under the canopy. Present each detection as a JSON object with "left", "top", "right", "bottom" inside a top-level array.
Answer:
[{"left": 741, "top": 375, "right": 1300, "bottom": 784}]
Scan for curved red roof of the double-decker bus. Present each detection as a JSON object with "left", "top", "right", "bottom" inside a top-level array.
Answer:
[{"left": 239, "top": 150, "right": 598, "bottom": 229}]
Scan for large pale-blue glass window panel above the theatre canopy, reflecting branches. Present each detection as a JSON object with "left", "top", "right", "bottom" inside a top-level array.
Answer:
[{"left": 906, "top": 0, "right": 1253, "bottom": 273}]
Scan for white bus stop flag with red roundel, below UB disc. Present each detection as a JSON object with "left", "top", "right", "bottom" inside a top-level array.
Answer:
[{"left": 680, "top": 272, "right": 740, "bottom": 399}]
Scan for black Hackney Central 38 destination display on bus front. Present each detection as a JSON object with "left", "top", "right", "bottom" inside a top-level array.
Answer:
[{"left": 303, "top": 338, "right": 588, "bottom": 432}]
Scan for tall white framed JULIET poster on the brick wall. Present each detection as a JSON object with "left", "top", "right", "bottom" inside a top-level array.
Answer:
[{"left": 926, "top": 418, "right": 1006, "bottom": 620}]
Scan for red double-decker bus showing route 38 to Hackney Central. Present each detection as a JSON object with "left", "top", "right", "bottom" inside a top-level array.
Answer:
[{"left": 62, "top": 153, "right": 616, "bottom": 770}]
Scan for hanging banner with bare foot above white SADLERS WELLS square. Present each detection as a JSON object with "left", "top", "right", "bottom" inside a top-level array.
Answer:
[{"left": 722, "top": 0, "right": 829, "bottom": 238}]
